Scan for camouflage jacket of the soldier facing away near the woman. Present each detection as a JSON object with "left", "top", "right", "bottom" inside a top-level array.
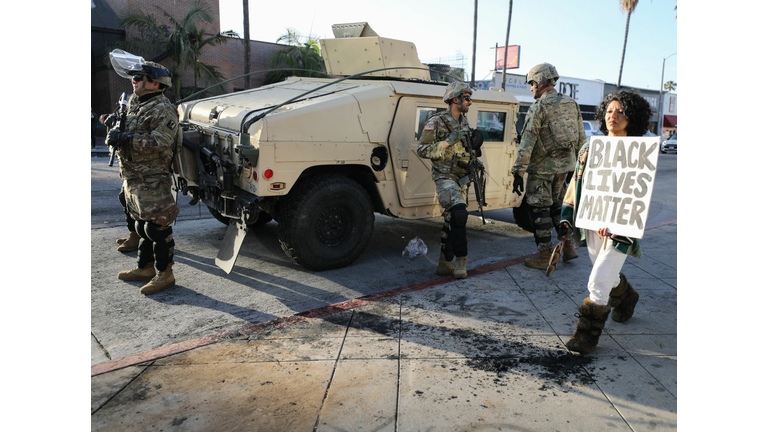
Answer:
[{"left": 512, "top": 89, "right": 587, "bottom": 177}]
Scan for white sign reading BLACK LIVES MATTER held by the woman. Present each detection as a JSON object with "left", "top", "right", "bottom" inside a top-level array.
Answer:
[{"left": 575, "top": 136, "right": 659, "bottom": 239}]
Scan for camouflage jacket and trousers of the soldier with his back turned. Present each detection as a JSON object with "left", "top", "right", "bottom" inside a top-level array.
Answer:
[{"left": 512, "top": 89, "right": 587, "bottom": 251}]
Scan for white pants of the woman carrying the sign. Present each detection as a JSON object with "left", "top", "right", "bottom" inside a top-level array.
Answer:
[{"left": 584, "top": 230, "right": 627, "bottom": 306}]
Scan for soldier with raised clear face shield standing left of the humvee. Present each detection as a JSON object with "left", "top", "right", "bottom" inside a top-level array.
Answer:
[{"left": 107, "top": 62, "right": 181, "bottom": 295}]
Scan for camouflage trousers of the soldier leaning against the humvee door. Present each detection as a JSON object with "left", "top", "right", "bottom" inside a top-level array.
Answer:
[{"left": 435, "top": 179, "right": 468, "bottom": 261}]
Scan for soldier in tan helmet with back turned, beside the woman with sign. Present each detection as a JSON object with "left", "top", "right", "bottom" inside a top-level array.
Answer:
[{"left": 512, "top": 63, "right": 587, "bottom": 270}]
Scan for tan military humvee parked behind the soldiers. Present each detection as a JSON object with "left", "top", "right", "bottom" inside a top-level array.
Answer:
[{"left": 174, "top": 23, "right": 522, "bottom": 272}]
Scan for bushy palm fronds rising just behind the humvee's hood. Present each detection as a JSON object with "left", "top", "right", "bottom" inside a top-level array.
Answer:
[{"left": 265, "top": 28, "right": 327, "bottom": 84}]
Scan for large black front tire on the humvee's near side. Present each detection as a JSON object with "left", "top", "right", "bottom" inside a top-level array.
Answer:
[{"left": 278, "top": 176, "right": 373, "bottom": 270}]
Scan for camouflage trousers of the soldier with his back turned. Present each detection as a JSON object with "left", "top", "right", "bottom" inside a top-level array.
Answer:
[{"left": 525, "top": 173, "right": 570, "bottom": 251}]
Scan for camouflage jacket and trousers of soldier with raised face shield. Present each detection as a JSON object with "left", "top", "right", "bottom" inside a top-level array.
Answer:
[{"left": 117, "top": 92, "right": 181, "bottom": 271}]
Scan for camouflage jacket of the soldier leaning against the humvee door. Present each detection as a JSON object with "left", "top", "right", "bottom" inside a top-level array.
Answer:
[{"left": 416, "top": 110, "right": 476, "bottom": 180}]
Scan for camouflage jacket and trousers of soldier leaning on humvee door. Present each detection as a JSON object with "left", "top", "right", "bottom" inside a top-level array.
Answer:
[{"left": 417, "top": 110, "right": 470, "bottom": 261}]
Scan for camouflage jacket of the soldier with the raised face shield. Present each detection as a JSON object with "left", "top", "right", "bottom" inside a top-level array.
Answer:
[{"left": 117, "top": 93, "right": 181, "bottom": 182}]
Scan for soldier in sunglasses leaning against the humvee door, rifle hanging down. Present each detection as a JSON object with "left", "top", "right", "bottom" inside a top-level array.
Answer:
[{"left": 418, "top": 81, "right": 481, "bottom": 279}]
